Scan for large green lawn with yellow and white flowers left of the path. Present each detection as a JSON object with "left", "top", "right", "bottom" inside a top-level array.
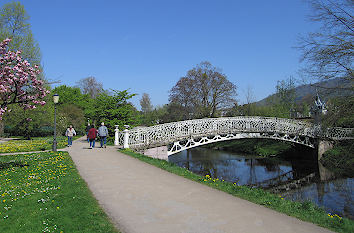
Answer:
[{"left": 0, "top": 152, "right": 117, "bottom": 233}]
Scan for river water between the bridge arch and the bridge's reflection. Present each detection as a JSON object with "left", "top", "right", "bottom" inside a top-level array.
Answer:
[{"left": 169, "top": 148, "right": 314, "bottom": 185}]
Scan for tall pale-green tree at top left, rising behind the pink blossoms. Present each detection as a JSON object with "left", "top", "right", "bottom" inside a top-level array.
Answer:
[{"left": 0, "top": 2, "right": 41, "bottom": 65}]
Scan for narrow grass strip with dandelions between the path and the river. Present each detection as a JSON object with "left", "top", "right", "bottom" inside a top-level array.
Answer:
[{"left": 120, "top": 149, "right": 354, "bottom": 232}]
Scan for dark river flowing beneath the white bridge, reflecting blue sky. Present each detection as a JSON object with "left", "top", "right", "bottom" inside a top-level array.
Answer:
[{"left": 169, "top": 147, "right": 354, "bottom": 219}]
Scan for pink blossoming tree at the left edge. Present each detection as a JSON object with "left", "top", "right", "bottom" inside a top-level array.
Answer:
[{"left": 0, "top": 39, "right": 49, "bottom": 120}]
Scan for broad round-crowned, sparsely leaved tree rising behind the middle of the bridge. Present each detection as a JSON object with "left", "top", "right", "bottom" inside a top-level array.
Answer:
[{"left": 169, "top": 62, "right": 236, "bottom": 119}]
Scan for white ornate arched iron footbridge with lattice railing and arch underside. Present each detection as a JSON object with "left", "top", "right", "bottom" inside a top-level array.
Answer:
[{"left": 115, "top": 116, "right": 354, "bottom": 155}]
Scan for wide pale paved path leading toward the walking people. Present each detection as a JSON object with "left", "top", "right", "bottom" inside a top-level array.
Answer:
[{"left": 67, "top": 139, "right": 330, "bottom": 233}]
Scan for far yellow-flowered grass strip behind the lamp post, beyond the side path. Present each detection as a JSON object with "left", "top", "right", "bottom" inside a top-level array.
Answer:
[{"left": 0, "top": 136, "right": 81, "bottom": 154}]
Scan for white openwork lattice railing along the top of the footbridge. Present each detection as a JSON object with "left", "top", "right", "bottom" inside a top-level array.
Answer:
[{"left": 119, "top": 116, "right": 354, "bottom": 147}]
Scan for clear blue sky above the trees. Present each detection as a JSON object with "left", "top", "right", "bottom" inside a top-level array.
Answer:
[{"left": 1, "top": 0, "right": 316, "bottom": 108}]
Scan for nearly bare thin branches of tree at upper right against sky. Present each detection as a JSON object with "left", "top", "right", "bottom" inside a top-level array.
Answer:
[{"left": 298, "top": 0, "right": 354, "bottom": 90}]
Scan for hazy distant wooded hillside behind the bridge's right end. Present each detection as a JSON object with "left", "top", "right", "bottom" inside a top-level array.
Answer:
[{"left": 256, "top": 79, "right": 354, "bottom": 106}]
